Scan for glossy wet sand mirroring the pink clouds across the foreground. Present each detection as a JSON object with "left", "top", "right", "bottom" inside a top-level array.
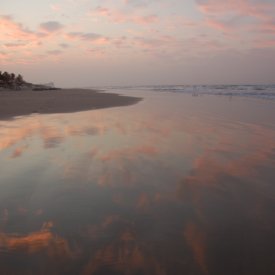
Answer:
[{"left": 0, "top": 94, "right": 275, "bottom": 274}]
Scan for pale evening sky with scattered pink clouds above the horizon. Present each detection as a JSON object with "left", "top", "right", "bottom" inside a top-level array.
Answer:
[{"left": 0, "top": 0, "right": 275, "bottom": 87}]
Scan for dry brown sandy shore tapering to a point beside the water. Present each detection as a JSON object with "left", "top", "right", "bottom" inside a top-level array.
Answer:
[{"left": 0, "top": 89, "right": 141, "bottom": 119}]
